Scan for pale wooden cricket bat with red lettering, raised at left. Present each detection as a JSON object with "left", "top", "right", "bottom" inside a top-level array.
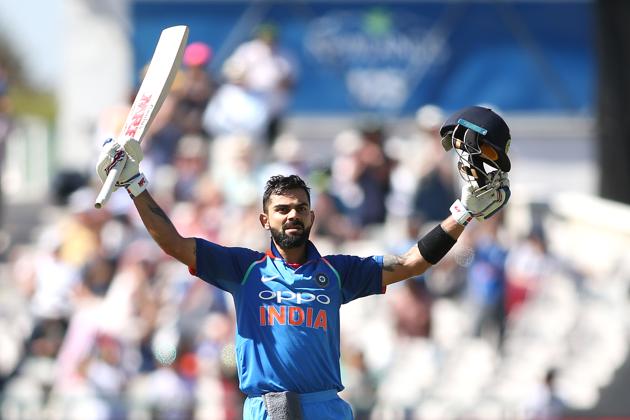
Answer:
[{"left": 94, "top": 25, "right": 188, "bottom": 209}]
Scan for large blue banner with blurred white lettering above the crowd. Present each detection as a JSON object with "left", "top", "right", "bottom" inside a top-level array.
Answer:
[{"left": 133, "top": 1, "right": 595, "bottom": 115}]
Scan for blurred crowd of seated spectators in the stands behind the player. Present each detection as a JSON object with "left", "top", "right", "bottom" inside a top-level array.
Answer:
[{"left": 0, "top": 26, "right": 620, "bottom": 420}]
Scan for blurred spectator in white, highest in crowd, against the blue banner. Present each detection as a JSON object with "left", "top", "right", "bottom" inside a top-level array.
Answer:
[{"left": 223, "top": 24, "right": 296, "bottom": 144}]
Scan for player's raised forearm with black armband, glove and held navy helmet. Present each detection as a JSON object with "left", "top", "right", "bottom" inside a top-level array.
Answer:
[{"left": 382, "top": 106, "right": 512, "bottom": 286}]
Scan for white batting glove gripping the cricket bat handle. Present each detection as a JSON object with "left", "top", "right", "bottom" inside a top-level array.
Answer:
[{"left": 96, "top": 138, "right": 148, "bottom": 198}]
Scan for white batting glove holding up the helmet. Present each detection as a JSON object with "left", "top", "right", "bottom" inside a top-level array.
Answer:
[{"left": 450, "top": 171, "right": 511, "bottom": 226}]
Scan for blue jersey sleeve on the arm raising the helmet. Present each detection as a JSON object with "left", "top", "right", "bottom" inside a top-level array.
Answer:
[{"left": 326, "top": 255, "right": 385, "bottom": 303}]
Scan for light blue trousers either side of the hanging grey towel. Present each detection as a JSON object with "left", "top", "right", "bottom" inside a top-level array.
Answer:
[{"left": 243, "top": 389, "right": 353, "bottom": 420}]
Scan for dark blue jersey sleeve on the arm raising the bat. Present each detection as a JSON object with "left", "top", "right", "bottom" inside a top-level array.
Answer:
[{"left": 193, "top": 238, "right": 264, "bottom": 293}]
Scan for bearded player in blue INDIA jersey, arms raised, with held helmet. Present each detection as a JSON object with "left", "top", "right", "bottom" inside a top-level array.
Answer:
[{"left": 97, "top": 107, "right": 510, "bottom": 420}]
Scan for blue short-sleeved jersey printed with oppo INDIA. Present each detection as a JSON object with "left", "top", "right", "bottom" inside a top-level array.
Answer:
[{"left": 195, "top": 239, "right": 384, "bottom": 396}]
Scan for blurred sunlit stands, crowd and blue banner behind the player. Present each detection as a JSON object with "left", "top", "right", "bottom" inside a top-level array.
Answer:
[{"left": 0, "top": 0, "right": 630, "bottom": 420}]
